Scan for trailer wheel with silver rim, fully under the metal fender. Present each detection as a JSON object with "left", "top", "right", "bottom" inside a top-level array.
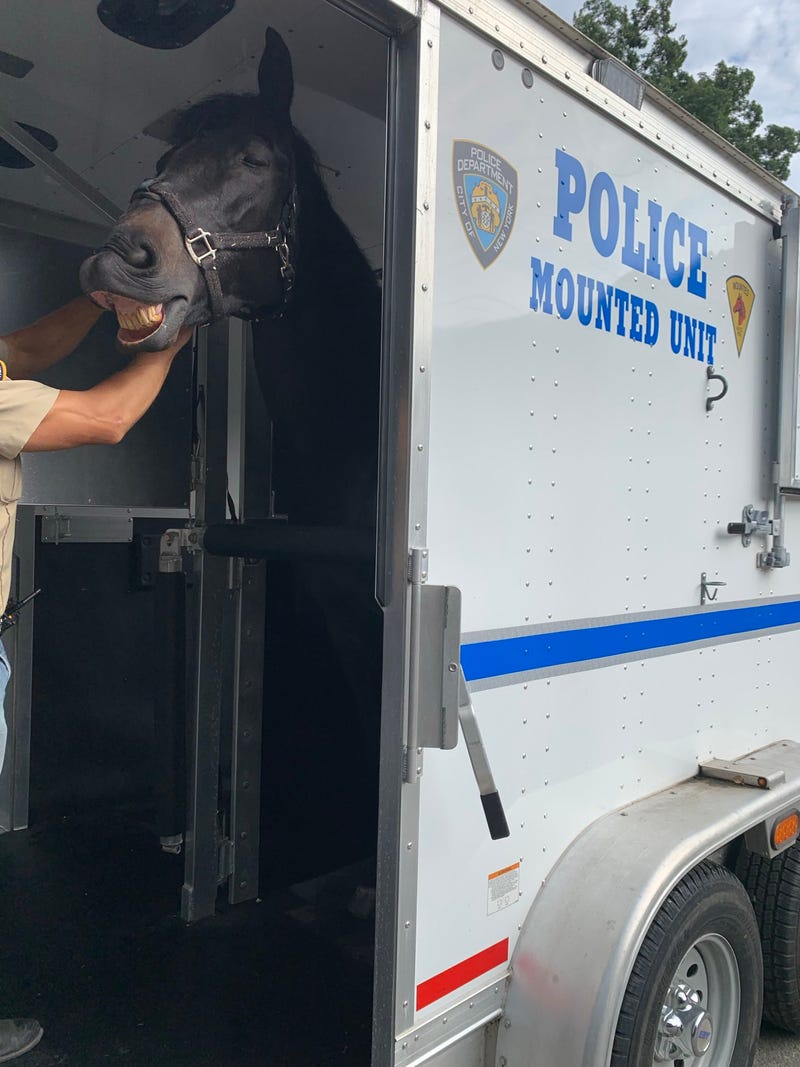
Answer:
[{"left": 611, "top": 861, "right": 762, "bottom": 1067}]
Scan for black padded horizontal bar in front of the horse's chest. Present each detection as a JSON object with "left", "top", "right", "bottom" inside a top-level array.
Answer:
[{"left": 203, "top": 520, "right": 375, "bottom": 561}]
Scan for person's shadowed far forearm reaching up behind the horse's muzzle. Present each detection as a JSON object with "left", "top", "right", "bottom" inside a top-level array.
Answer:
[{"left": 0, "top": 297, "right": 102, "bottom": 379}]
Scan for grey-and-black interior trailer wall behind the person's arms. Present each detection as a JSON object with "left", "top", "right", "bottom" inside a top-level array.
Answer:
[{"left": 0, "top": 227, "right": 192, "bottom": 828}]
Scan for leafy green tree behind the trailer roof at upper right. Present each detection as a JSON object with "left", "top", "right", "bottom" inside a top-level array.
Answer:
[{"left": 574, "top": 0, "right": 800, "bottom": 180}]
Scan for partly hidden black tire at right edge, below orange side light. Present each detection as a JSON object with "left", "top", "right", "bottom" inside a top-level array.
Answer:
[{"left": 736, "top": 842, "right": 800, "bottom": 1034}]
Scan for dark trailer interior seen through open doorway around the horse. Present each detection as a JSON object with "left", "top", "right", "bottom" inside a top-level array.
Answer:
[{"left": 0, "top": 0, "right": 389, "bottom": 1067}]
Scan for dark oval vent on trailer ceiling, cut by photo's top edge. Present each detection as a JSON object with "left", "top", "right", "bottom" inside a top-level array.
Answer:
[{"left": 97, "top": 0, "right": 236, "bottom": 48}]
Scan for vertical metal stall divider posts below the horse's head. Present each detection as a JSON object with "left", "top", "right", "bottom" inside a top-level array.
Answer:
[{"left": 159, "top": 311, "right": 266, "bottom": 922}]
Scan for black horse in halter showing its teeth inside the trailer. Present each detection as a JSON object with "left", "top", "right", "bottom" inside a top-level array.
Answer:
[{"left": 81, "top": 30, "right": 381, "bottom": 870}]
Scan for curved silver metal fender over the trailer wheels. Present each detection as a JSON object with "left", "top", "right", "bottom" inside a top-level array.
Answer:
[{"left": 495, "top": 740, "right": 800, "bottom": 1067}]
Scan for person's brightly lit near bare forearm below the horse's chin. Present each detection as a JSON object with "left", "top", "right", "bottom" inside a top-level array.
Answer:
[{"left": 22, "top": 327, "right": 192, "bottom": 452}]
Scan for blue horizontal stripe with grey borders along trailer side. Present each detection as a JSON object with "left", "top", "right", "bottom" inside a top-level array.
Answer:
[{"left": 461, "top": 598, "right": 800, "bottom": 691}]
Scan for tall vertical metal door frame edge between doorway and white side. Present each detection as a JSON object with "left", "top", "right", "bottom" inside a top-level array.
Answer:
[{"left": 372, "top": 10, "right": 419, "bottom": 1064}]
